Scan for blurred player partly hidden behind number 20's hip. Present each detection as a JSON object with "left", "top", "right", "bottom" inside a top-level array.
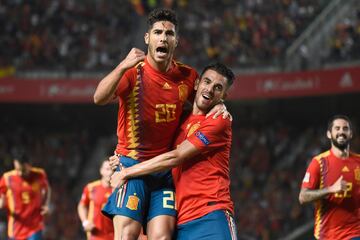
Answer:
[{"left": 78, "top": 159, "right": 114, "bottom": 240}]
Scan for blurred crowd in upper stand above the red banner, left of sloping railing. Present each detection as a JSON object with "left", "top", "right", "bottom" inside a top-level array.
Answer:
[{"left": 0, "top": 0, "right": 327, "bottom": 72}]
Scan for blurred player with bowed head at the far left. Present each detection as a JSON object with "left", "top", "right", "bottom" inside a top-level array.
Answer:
[{"left": 0, "top": 152, "right": 50, "bottom": 240}]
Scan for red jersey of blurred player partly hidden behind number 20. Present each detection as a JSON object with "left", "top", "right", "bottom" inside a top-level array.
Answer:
[{"left": 80, "top": 180, "right": 114, "bottom": 240}]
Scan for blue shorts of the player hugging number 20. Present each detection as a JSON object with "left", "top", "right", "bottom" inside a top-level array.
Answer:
[{"left": 176, "top": 210, "right": 237, "bottom": 240}]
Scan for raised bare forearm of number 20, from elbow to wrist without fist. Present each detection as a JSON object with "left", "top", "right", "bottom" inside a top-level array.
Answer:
[{"left": 94, "top": 64, "right": 125, "bottom": 105}]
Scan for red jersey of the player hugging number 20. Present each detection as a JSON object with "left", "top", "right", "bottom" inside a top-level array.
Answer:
[{"left": 173, "top": 115, "right": 233, "bottom": 224}]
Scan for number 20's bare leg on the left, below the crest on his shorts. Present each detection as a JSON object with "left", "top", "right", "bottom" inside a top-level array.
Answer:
[{"left": 113, "top": 215, "right": 142, "bottom": 240}]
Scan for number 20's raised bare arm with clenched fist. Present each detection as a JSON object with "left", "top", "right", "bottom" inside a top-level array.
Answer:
[{"left": 94, "top": 48, "right": 145, "bottom": 105}]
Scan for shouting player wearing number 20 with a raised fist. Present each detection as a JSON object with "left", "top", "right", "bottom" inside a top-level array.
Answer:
[{"left": 94, "top": 9, "right": 226, "bottom": 239}]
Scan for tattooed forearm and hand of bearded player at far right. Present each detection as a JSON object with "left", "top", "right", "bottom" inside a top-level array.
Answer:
[{"left": 299, "top": 176, "right": 346, "bottom": 204}]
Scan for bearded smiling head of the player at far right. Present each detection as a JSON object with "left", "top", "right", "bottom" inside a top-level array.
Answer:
[{"left": 328, "top": 119, "right": 352, "bottom": 150}]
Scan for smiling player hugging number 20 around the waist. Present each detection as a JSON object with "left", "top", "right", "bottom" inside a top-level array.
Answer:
[{"left": 111, "top": 63, "right": 237, "bottom": 240}]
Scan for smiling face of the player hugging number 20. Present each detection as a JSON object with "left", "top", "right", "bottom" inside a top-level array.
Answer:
[{"left": 195, "top": 69, "right": 227, "bottom": 113}]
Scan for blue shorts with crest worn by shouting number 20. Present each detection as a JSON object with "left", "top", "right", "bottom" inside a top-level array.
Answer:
[{"left": 102, "top": 156, "right": 176, "bottom": 225}]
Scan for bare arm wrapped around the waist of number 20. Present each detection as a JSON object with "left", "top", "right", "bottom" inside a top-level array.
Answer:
[{"left": 110, "top": 140, "right": 200, "bottom": 187}]
